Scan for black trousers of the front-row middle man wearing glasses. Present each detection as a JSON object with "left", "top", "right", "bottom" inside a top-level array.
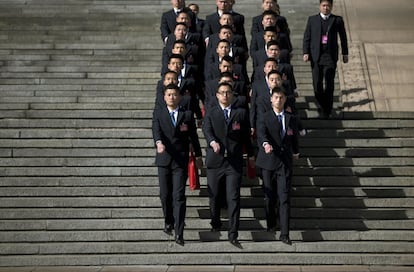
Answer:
[{"left": 207, "top": 160, "right": 241, "bottom": 240}]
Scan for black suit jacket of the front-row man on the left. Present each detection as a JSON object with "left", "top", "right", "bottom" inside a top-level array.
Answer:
[{"left": 152, "top": 106, "right": 201, "bottom": 169}]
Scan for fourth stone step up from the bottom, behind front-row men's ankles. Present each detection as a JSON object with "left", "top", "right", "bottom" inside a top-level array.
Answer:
[{"left": 0, "top": 218, "right": 414, "bottom": 231}]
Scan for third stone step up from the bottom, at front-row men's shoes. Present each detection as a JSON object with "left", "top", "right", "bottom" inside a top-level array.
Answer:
[{"left": 0, "top": 229, "right": 414, "bottom": 243}]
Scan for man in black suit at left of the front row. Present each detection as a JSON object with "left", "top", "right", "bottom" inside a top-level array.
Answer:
[{"left": 152, "top": 84, "right": 202, "bottom": 246}]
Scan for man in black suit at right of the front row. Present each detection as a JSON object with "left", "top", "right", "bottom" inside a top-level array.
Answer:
[{"left": 256, "top": 87, "right": 299, "bottom": 245}]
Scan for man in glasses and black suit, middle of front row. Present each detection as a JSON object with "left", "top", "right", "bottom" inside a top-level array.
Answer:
[{"left": 203, "top": 83, "right": 254, "bottom": 248}]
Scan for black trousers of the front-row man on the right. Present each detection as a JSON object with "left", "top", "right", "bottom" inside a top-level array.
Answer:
[{"left": 262, "top": 166, "right": 291, "bottom": 235}]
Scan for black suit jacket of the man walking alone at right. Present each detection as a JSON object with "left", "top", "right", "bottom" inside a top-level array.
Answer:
[{"left": 303, "top": 14, "right": 348, "bottom": 63}]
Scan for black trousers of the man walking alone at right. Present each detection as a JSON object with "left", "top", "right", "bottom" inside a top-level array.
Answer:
[{"left": 311, "top": 60, "right": 336, "bottom": 114}]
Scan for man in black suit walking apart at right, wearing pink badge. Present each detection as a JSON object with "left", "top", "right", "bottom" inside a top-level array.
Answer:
[{"left": 303, "top": 0, "right": 348, "bottom": 118}]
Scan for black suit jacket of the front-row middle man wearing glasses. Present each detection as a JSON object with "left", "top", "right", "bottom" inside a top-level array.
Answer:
[{"left": 203, "top": 106, "right": 253, "bottom": 172}]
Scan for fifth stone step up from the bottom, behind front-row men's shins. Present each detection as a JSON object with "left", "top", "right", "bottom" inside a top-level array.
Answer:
[{"left": 0, "top": 207, "right": 414, "bottom": 221}]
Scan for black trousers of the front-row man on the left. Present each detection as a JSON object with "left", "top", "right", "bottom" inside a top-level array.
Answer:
[{"left": 158, "top": 162, "right": 188, "bottom": 235}]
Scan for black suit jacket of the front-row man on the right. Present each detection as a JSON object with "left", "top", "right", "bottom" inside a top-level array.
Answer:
[{"left": 256, "top": 110, "right": 299, "bottom": 170}]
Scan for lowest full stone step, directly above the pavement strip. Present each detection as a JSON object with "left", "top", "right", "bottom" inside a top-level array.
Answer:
[{"left": 2, "top": 253, "right": 414, "bottom": 266}]
